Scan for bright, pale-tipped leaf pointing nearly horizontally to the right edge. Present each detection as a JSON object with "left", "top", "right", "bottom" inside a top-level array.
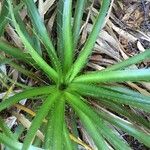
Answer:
[{"left": 74, "top": 69, "right": 150, "bottom": 83}]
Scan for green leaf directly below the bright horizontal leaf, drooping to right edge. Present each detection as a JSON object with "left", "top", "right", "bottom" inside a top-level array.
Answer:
[{"left": 70, "top": 83, "right": 150, "bottom": 112}]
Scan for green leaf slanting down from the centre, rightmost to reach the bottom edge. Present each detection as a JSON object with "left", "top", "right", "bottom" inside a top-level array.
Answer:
[{"left": 67, "top": 93, "right": 130, "bottom": 150}]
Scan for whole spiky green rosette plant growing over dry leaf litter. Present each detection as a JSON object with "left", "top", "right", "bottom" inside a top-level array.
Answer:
[{"left": 0, "top": 0, "right": 150, "bottom": 150}]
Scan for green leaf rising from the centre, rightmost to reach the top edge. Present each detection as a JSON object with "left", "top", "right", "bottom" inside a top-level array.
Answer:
[{"left": 67, "top": 0, "right": 110, "bottom": 81}]
